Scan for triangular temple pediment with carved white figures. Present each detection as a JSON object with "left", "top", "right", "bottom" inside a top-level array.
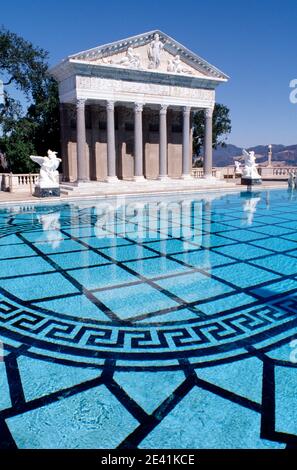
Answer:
[{"left": 69, "top": 30, "right": 228, "bottom": 80}]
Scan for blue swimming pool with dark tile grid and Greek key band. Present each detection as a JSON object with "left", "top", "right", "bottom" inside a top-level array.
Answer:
[{"left": 0, "top": 190, "right": 297, "bottom": 449}]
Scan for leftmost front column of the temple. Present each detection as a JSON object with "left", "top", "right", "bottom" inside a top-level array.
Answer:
[{"left": 76, "top": 99, "right": 89, "bottom": 183}]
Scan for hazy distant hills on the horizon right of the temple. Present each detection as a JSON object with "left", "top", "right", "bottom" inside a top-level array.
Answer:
[{"left": 213, "top": 144, "right": 297, "bottom": 166}]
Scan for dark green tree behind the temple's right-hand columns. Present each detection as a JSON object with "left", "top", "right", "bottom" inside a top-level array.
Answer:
[{"left": 193, "top": 104, "right": 231, "bottom": 156}]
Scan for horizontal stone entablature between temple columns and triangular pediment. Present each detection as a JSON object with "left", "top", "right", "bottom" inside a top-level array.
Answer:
[{"left": 59, "top": 64, "right": 215, "bottom": 108}]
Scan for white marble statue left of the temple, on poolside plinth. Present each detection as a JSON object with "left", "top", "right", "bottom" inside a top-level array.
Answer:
[{"left": 30, "top": 150, "right": 61, "bottom": 188}]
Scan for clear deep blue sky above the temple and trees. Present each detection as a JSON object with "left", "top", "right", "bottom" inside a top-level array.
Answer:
[{"left": 0, "top": 0, "right": 297, "bottom": 147}]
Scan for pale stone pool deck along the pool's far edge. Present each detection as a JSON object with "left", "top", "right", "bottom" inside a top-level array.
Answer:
[{"left": 0, "top": 179, "right": 288, "bottom": 204}]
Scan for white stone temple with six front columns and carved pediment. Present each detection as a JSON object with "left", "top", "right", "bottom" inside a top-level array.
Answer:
[{"left": 51, "top": 31, "right": 228, "bottom": 184}]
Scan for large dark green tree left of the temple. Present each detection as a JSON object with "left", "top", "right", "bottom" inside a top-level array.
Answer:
[{"left": 0, "top": 28, "right": 60, "bottom": 173}]
